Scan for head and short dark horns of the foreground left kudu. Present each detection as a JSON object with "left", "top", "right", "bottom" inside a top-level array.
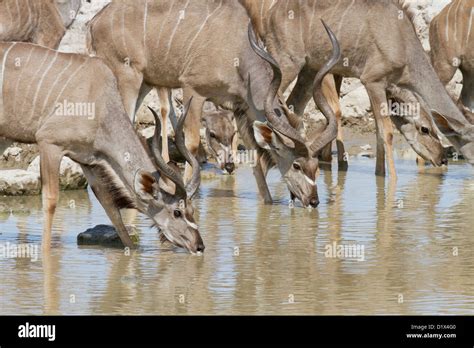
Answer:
[{"left": 140, "top": 100, "right": 205, "bottom": 254}]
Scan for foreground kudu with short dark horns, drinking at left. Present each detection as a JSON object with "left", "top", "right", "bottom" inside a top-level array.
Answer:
[{"left": 0, "top": 43, "right": 204, "bottom": 253}]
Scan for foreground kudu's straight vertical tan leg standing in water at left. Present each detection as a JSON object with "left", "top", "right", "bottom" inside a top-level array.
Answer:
[{"left": 38, "top": 143, "right": 63, "bottom": 249}]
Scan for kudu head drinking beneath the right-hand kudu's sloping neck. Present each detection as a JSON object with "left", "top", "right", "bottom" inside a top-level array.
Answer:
[{"left": 387, "top": 85, "right": 448, "bottom": 167}]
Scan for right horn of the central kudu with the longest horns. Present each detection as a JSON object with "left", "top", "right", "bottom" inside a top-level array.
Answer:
[{"left": 309, "top": 19, "right": 341, "bottom": 156}]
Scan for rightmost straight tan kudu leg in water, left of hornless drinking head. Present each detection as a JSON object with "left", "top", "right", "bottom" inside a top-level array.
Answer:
[{"left": 365, "top": 83, "right": 397, "bottom": 179}]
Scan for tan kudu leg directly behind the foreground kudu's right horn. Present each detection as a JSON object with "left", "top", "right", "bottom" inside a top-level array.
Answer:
[{"left": 183, "top": 89, "right": 206, "bottom": 183}]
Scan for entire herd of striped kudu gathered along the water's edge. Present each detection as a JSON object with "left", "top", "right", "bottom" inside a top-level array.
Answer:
[{"left": 0, "top": 0, "right": 474, "bottom": 253}]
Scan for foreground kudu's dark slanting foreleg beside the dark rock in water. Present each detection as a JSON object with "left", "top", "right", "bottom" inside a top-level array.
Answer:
[{"left": 81, "top": 165, "right": 135, "bottom": 249}]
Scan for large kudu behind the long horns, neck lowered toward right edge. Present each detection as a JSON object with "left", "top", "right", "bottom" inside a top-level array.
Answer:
[{"left": 240, "top": 0, "right": 474, "bottom": 171}]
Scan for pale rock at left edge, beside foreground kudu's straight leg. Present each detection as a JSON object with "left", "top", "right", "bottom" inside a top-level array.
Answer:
[{"left": 0, "top": 169, "right": 41, "bottom": 196}]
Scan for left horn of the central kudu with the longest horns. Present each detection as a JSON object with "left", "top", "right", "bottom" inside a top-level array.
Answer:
[{"left": 248, "top": 23, "right": 305, "bottom": 145}]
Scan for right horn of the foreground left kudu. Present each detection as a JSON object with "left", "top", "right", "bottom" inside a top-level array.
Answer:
[{"left": 170, "top": 97, "right": 201, "bottom": 198}]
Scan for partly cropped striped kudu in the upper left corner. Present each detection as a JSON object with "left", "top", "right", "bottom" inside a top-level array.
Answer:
[{"left": 0, "top": 0, "right": 81, "bottom": 49}]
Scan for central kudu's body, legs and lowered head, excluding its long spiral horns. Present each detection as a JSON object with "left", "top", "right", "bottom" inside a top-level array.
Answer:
[{"left": 88, "top": 0, "right": 332, "bottom": 206}]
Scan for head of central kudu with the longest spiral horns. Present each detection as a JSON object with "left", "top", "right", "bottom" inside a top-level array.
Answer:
[{"left": 248, "top": 22, "right": 341, "bottom": 207}]
